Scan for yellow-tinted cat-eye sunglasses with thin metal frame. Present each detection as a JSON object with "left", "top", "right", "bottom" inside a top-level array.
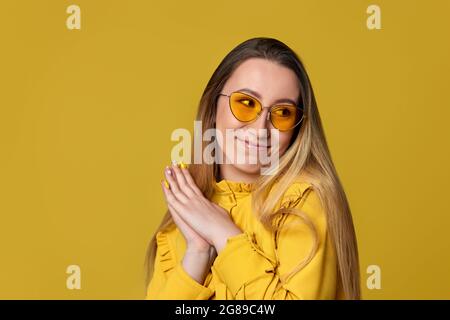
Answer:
[{"left": 219, "top": 91, "right": 304, "bottom": 131}]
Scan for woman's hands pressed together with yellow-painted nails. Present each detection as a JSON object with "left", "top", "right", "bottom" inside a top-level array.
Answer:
[{"left": 161, "top": 163, "right": 242, "bottom": 254}]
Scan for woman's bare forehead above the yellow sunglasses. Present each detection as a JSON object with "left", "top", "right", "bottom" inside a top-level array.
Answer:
[{"left": 224, "top": 58, "right": 300, "bottom": 103}]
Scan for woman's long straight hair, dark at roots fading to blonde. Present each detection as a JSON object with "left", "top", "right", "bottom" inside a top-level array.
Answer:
[{"left": 144, "top": 37, "right": 361, "bottom": 299}]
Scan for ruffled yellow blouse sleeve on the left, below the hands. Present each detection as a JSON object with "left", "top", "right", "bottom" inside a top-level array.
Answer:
[{"left": 145, "top": 232, "right": 214, "bottom": 300}]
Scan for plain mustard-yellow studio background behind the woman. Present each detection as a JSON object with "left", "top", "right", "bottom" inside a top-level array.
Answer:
[{"left": 0, "top": 0, "right": 450, "bottom": 299}]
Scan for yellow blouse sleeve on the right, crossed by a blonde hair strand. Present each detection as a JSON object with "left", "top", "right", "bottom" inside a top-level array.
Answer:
[{"left": 209, "top": 188, "right": 337, "bottom": 300}]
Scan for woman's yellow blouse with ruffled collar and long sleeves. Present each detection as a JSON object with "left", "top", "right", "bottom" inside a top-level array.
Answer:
[{"left": 146, "top": 180, "right": 344, "bottom": 300}]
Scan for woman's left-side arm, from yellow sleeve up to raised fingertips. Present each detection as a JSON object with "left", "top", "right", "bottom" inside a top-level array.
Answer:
[{"left": 146, "top": 167, "right": 216, "bottom": 300}]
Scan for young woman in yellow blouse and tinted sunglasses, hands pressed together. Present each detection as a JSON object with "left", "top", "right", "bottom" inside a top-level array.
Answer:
[{"left": 145, "top": 38, "right": 360, "bottom": 300}]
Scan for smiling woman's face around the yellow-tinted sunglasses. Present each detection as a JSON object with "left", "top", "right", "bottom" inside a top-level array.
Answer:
[{"left": 216, "top": 58, "right": 301, "bottom": 181}]
